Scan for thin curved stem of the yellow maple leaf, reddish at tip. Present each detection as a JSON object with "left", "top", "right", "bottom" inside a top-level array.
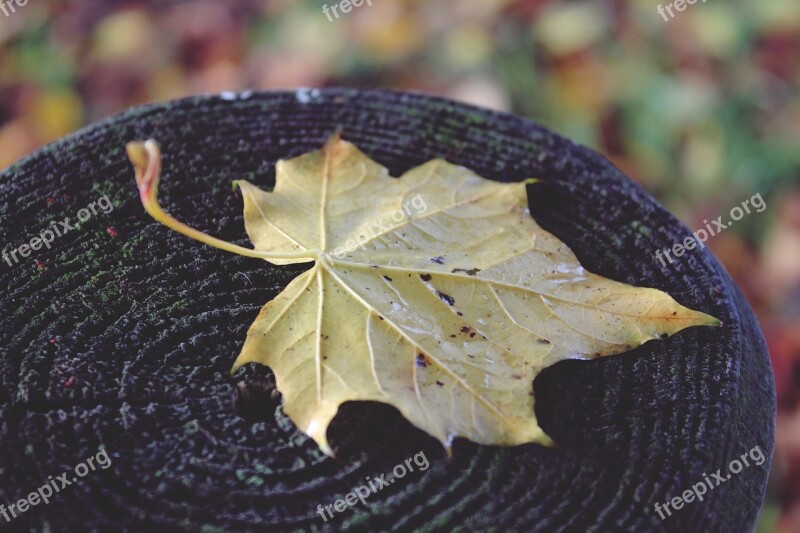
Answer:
[{"left": 126, "top": 139, "right": 316, "bottom": 260}]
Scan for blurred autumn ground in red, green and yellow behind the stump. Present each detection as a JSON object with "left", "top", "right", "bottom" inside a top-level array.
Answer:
[{"left": 0, "top": 0, "right": 800, "bottom": 532}]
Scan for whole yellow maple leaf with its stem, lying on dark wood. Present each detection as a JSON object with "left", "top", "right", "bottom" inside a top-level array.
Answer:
[{"left": 128, "top": 136, "right": 719, "bottom": 455}]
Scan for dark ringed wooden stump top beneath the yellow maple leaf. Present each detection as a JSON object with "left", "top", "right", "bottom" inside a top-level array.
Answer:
[{"left": 0, "top": 89, "right": 775, "bottom": 531}]
